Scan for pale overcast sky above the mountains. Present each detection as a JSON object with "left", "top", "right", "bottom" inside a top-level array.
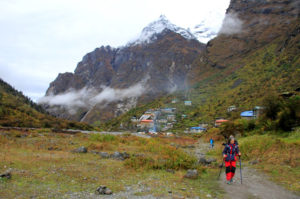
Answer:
[{"left": 0, "top": 0, "right": 230, "bottom": 100}]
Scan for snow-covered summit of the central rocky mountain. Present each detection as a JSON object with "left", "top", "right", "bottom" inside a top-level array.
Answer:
[{"left": 129, "top": 15, "right": 197, "bottom": 45}]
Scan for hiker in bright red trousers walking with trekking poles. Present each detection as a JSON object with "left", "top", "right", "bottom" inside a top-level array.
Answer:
[{"left": 223, "top": 136, "right": 241, "bottom": 184}]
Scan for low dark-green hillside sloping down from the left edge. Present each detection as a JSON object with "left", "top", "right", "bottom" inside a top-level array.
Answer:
[{"left": 0, "top": 79, "right": 91, "bottom": 129}]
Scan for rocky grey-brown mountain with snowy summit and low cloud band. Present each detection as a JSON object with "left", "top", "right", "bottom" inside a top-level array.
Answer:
[{"left": 41, "top": 16, "right": 205, "bottom": 123}]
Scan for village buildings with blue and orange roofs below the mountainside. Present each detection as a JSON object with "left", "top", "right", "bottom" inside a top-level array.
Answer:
[{"left": 131, "top": 99, "right": 263, "bottom": 136}]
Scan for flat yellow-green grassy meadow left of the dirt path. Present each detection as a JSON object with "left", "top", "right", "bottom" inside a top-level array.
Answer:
[{"left": 0, "top": 131, "right": 222, "bottom": 198}]
